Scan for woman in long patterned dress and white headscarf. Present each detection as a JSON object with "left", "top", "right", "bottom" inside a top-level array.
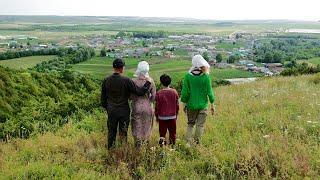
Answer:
[{"left": 130, "top": 61, "right": 156, "bottom": 148}]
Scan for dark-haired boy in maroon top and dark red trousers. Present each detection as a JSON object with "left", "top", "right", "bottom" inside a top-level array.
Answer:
[{"left": 155, "top": 74, "right": 179, "bottom": 147}]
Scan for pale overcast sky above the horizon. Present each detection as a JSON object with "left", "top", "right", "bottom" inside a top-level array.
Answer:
[{"left": 0, "top": 0, "right": 320, "bottom": 20}]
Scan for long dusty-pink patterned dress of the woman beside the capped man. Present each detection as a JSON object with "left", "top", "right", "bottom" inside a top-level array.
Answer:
[{"left": 131, "top": 78, "right": 156, "bottom": 141}]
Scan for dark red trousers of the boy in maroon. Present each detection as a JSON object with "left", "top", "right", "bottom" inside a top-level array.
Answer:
[{"left": 159, "top": 119, "right": 177, "bottom": 145}]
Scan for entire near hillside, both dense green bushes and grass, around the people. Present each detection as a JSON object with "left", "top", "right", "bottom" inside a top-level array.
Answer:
[{"left": 0, "top": 65, "right": 320, "bottom": 179}]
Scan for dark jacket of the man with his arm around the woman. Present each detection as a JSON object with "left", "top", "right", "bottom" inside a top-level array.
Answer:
[{"left": 101, "top": 73, "right": 150, "bottom": 112}]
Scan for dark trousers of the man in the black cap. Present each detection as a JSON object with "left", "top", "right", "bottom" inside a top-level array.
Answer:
[{"left": 107, "top": 108, "right": 130, "bottom": 149}]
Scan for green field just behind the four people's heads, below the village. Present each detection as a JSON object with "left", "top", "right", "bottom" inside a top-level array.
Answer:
[{"left": 72, "top": 57, "right": 260, "bottom": 83}]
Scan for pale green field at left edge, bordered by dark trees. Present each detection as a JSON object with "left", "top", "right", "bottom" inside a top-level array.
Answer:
[{"left": 0, "top": 56, "right": 56, "bottom": 69}]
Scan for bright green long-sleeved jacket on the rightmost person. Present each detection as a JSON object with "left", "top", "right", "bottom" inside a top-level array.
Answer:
[{"left": 181, "top": 73, "right": 215, "bottom": 110}]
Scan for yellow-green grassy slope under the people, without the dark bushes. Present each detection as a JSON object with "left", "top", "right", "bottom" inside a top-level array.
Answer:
[{"left": 0, "top": 71, "right": 320, "bottom": 179}]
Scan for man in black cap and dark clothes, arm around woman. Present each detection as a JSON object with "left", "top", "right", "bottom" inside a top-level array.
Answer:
[{"left": 101, "top": 59, "right": 151, "bottom": 149}]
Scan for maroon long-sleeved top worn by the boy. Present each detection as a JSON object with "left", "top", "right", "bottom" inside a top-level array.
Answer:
[{"left": 155, "top": 88, "right": 179, "bottom": 119}]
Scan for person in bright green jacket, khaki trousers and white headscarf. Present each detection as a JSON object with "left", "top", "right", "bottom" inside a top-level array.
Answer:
[{"left": 181, "top": 55, "right": 215, "bottom": 145}]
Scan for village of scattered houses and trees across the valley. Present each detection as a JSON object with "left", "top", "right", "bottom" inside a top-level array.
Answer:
[{"left": 0, "top": 31, "right": 284, "bottom": 76}]
